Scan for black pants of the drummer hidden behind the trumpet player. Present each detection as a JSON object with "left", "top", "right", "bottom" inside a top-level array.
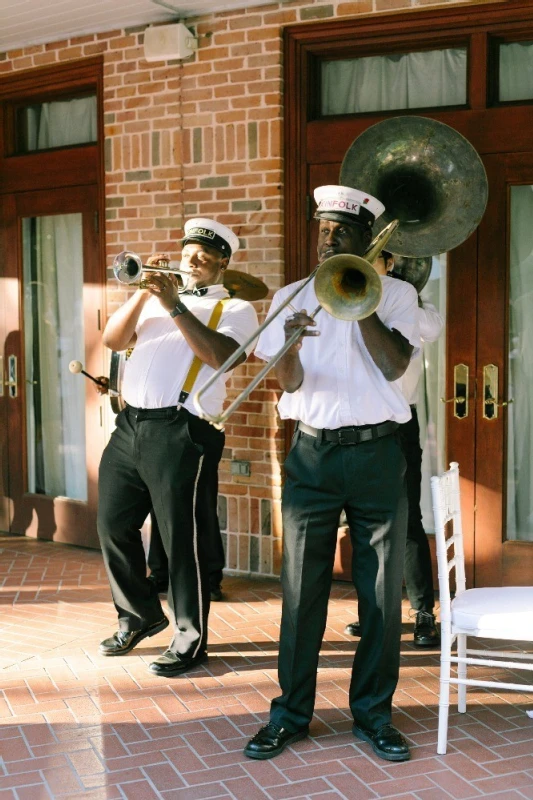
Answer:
[{"left": 147, "top": 433, "right": 226, "bottom": 589}]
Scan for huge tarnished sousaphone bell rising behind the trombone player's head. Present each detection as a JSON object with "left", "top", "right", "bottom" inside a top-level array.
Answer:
[{"left": 340, "top": 116, "right": 488, "bottom": 258}]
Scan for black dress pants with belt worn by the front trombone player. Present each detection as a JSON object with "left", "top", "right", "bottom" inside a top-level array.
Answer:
[{"left": 271, "top": 430, "right": 407, "bottom": 731}]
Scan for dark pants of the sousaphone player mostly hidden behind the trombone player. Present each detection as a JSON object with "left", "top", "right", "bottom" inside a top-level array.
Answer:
[{"left": 398, "top": 406, "right": 435, "bottom": 613}]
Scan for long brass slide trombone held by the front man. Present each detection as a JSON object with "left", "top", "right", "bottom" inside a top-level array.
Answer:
[{"left": 193, "top": 220, "right": 399, "bottom": 430}]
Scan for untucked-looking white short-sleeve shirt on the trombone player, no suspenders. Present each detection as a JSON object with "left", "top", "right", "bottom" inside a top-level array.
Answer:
[{"left": 255, "top": 276, "right": 420, "bottom": 428}]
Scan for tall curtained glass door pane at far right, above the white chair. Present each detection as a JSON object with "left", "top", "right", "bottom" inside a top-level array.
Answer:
[{"left": 506, "top": 186, "right": 533, "bottom": 542}]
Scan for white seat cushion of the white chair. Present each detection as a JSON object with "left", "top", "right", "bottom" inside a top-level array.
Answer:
[{"left": 452, "top": 586, "right": 533, "bottom": 641}]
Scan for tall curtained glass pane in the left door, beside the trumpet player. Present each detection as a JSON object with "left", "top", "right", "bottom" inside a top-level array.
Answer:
[{"left": 22, "top": 214, "right": 87, "bottom": 500}]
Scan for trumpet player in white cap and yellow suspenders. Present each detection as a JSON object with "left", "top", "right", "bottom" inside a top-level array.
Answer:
[{"left": 98, "top": 218, "right": 257, "bottom": 677}]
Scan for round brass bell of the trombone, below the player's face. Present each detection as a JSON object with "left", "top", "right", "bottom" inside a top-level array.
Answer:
[{"left": 315, "top": 253, "right": 382, "bottom": 322}]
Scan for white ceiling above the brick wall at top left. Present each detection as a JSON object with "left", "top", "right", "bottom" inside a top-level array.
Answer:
[{"left": 0, "top": 0, "right": 283, "bottom": 53}]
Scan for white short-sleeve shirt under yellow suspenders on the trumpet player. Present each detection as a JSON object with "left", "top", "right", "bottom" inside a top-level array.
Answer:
[{"left": 122, "top": 284, "right": 257, "bottom": 416}]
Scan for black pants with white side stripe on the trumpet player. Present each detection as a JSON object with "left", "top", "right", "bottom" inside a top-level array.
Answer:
[{"left": 98, "top": 407, "right": 223, "bottom": 657}]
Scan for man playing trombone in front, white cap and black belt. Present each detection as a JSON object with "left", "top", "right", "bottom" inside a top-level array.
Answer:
[{"left": 244, "top": 186, "right": 420, "bottom": 761}]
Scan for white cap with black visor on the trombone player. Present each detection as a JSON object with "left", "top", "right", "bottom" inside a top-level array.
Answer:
[{"left": 314, "top": 186, "right": 385, "bottom": 228}]
